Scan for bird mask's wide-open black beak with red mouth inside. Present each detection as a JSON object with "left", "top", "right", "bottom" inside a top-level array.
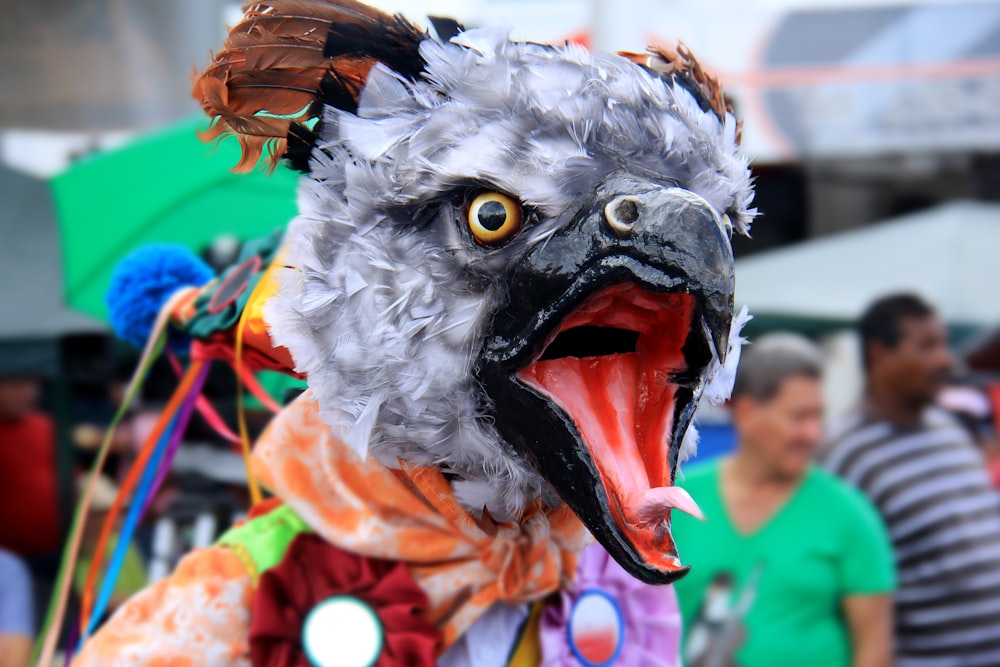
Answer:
[{"left": 479, "top": 175, "right": 734, "bottom": 583}]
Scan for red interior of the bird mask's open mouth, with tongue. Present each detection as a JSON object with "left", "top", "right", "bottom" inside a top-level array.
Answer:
[{"left": 518, "top": 284, "right": 695, "bottom": 569}]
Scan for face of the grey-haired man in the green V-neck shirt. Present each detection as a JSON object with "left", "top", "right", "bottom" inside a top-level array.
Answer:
[{"left": 733, "top": 375, "right": 823, "bottom": 478}]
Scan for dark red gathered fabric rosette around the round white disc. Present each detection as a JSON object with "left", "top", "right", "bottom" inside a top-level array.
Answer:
[{"left": 250, "top": 533, "right": 441, "bottom": 667}]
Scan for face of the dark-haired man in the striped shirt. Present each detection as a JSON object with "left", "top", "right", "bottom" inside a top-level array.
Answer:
[{"left": 871, "top": 317, "right": 951, "bottom": 407}]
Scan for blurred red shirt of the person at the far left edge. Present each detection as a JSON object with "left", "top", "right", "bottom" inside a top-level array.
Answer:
[{"left": 0, "top": 412, "right": 60, "bottom": 556}]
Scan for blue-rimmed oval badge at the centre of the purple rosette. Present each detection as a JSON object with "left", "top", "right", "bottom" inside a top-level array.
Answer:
[{"left": 567, "top": 588, "right": 625, "bottom": 667}]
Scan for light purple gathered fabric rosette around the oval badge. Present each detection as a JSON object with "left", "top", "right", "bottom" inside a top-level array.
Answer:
[{"left": 541, "top": 544, "right": 681, "bottom": 667}]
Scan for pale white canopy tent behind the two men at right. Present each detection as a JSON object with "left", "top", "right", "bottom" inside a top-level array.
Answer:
[{"left": 736, "top": 202, "right": 1000, "bottom": 330}]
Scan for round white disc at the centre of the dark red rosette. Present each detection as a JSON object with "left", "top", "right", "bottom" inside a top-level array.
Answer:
[{"left": 302, "top": 595, "right": 385, "bottom": 667}]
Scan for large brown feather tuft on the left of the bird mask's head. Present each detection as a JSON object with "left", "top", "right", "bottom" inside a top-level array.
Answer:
[{"left": 192, "top": 0, "right": 424, "bottom": 171}]
